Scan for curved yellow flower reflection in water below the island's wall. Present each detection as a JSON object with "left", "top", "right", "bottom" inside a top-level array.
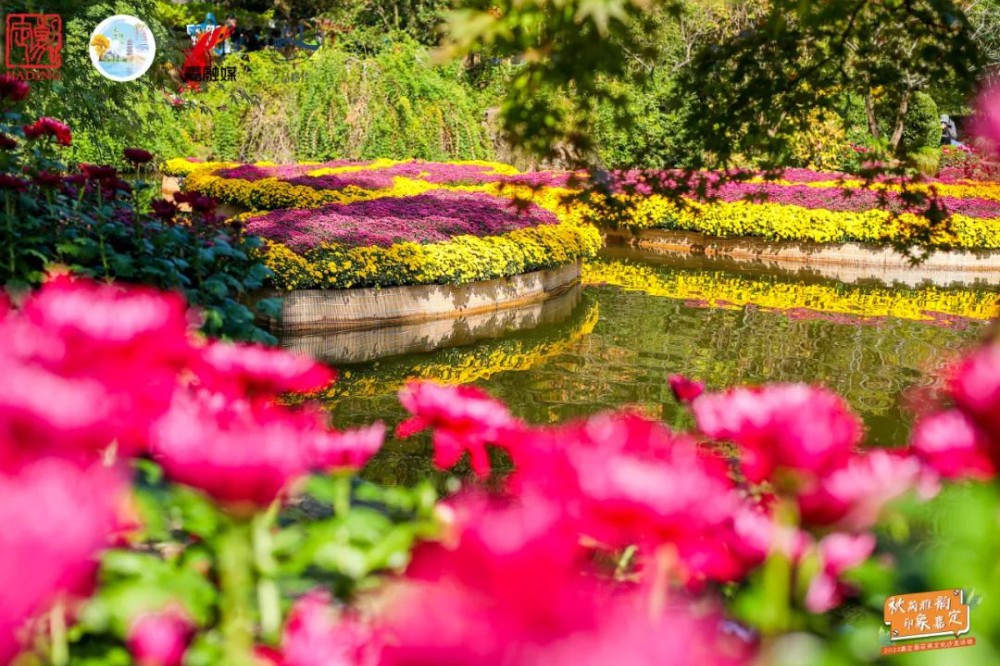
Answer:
[{"left": 309, "top": 301, "right": 600, "bottom": 401}]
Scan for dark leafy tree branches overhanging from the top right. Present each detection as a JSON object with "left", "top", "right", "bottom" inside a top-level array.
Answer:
[{"left": 446, "top": 0, "right": 982, "bottom": 168}]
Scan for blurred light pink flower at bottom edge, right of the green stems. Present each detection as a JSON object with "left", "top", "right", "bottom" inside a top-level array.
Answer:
[{"left": 281, "top": 591, "right": 381, "bottom": 666}]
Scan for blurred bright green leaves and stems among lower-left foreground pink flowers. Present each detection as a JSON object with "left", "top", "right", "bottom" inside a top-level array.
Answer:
[{"left": 68, "top": 460, "right": 438, "bottom": 666}]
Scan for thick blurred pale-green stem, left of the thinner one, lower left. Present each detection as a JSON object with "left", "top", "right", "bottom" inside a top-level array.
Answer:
[{"left": 218, "top": 521, "right": 254, "bottom": 666}]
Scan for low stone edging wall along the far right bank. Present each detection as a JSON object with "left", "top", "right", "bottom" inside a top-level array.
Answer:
[{"left": 604, "top": 229, "right": 1000, "bottom": 285}]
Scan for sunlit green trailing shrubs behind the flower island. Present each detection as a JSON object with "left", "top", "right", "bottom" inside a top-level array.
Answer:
[{"left": 148, "top": 37, "right": 491, "bottom": 162}]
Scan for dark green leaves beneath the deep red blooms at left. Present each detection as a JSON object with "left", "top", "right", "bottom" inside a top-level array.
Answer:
[{"left": 0, "top": 107, "right": 274, "bottom": 343}]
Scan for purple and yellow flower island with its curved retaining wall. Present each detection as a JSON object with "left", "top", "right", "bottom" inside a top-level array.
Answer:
[{"left": 166, "top": 160, "right": 601, "bottom": 332}]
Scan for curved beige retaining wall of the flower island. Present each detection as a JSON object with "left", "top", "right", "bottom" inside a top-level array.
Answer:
[{"left": 257, "top": 261, "right": 580, "bottom": 333}]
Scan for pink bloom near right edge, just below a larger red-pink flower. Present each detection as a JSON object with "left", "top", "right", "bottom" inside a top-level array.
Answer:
[{"left": 913, "top": 409, "right": 996, "bottom": 481}]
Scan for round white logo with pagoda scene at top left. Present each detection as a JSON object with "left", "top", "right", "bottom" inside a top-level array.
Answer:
[{"left": 90, "top": 14, "right": 156, "bottom": 81}]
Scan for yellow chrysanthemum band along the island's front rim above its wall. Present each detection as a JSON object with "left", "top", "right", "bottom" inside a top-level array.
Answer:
[{"left": 263, "top": 211, "right": 602, "bottom": 290}]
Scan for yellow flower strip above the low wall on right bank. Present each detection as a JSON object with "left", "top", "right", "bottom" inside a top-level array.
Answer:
[{"left": 617, "top": 196, "right": 1000, "bottom": 250}]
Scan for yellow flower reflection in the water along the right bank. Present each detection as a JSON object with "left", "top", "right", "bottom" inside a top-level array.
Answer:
[{"left": 583, "top": 260, "right": 1000, "bottom": 322}]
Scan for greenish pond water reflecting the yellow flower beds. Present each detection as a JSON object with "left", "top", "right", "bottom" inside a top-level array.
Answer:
[{"left": 283, "top": 250, "right": 997, "bottom": 484}]
